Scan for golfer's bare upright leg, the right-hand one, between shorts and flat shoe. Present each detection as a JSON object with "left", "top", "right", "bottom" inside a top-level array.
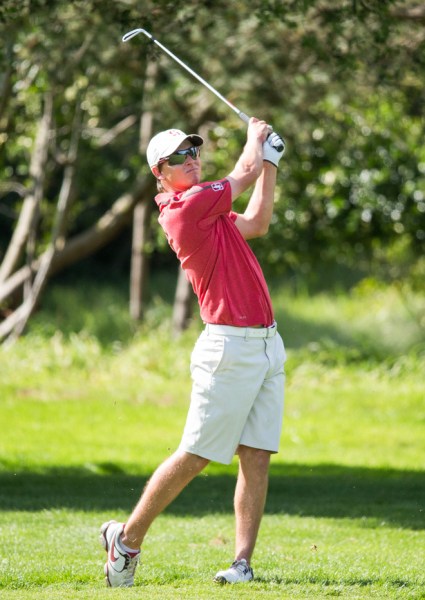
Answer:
[{"left": 235, "top": 446, "right": 270, "bottom": 564}]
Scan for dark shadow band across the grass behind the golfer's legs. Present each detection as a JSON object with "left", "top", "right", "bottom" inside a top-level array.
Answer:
[{"left": 0, "top": 464, "right": 425, "bottom": 529}]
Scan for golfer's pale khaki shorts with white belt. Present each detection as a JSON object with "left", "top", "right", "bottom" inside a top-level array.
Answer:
[{"left": 180, "top": 325, "right": 286, "bottom": 464}]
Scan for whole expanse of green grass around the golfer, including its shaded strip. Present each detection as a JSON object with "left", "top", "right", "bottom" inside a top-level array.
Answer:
[{"left": 0, "top": 281, "right": 425, "bottom": 600}]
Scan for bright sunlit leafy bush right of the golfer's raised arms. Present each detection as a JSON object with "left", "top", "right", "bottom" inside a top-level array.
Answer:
[{"left": 252, "top": 94, "right": 425, "bottom": 272}]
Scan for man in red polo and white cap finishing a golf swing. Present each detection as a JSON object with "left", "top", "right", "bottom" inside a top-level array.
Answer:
[{"left": 101, "top": 118, "right": 285, "bottom": 587}]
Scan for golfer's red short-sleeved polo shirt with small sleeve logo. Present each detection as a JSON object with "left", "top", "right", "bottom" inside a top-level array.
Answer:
[{"left": 155, "top": 179, "right": 274, "bottom": 327}]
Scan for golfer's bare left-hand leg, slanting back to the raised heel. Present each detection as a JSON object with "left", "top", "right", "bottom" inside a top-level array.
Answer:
[{"left": 121, "top": 450, "right": 209, "bottom": 549}]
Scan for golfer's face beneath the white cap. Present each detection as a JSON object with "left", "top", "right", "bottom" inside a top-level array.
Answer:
[{"left": 152, "top": 140, "right": 201, "bottom": 192}]
